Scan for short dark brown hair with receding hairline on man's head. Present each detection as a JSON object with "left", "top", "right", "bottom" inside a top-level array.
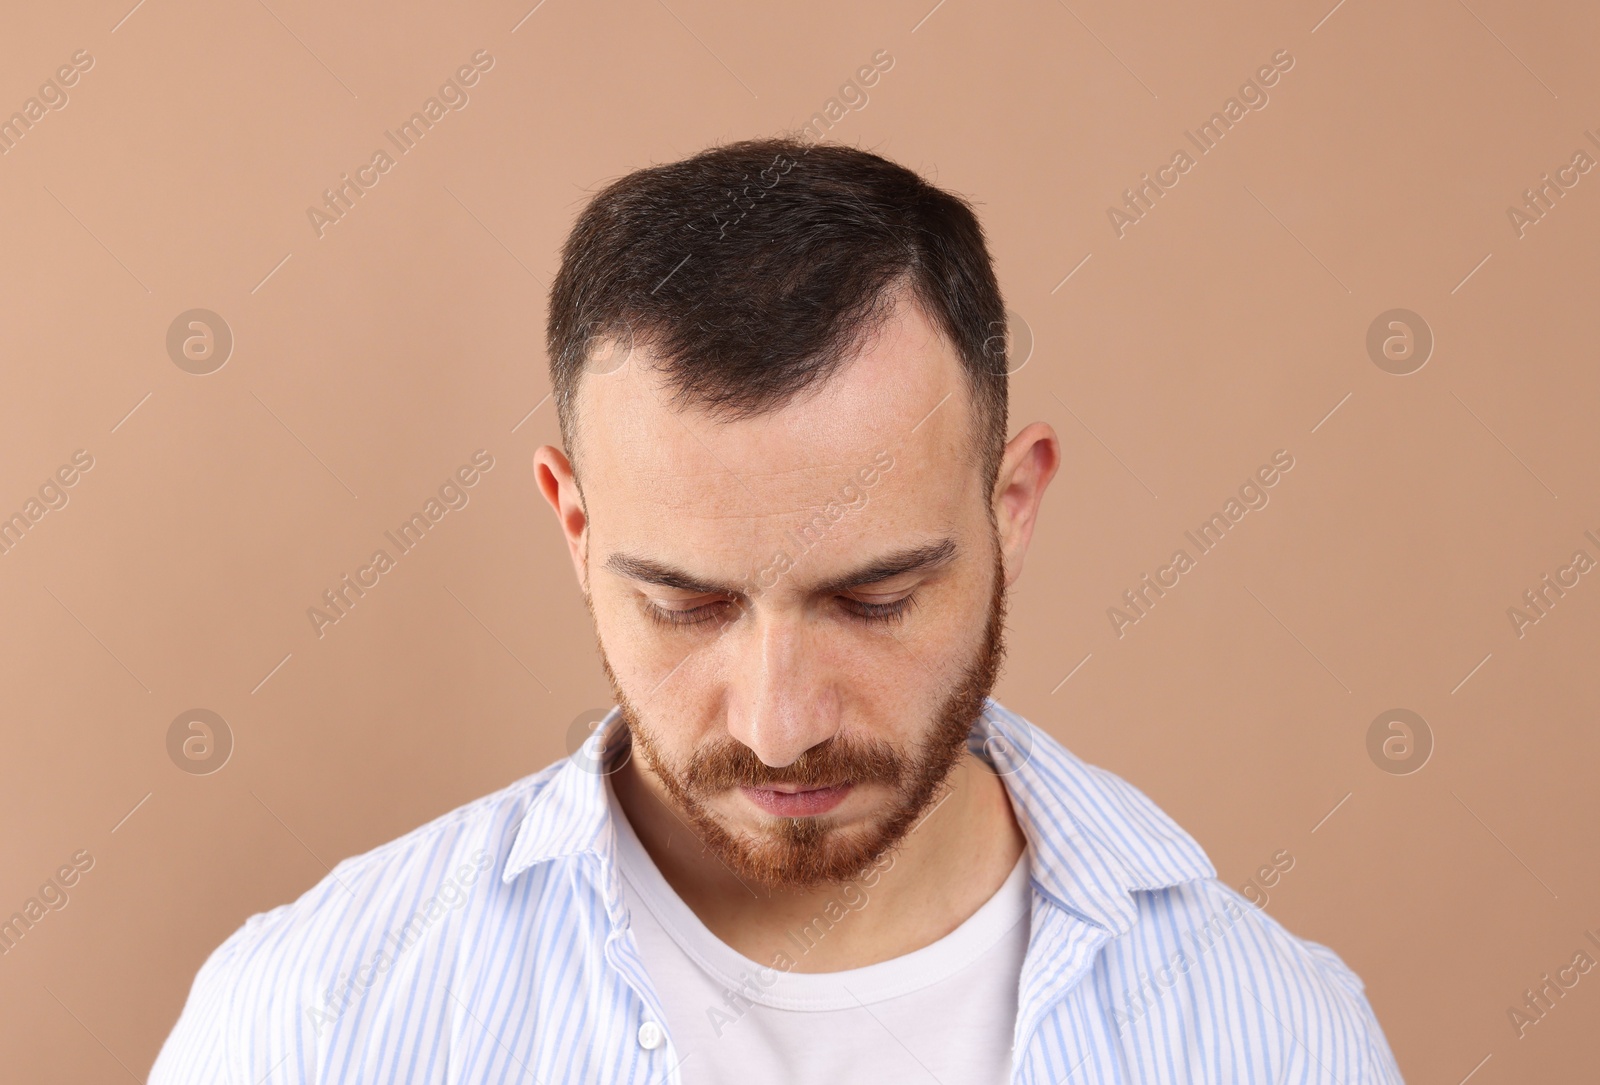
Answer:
[{"left": 546, "top": 139, "right": 1006, "bottom": 486}]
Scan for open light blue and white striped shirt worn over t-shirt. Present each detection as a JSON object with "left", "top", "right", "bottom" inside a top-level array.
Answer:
[{"left": 150, "top": 701, "right": 1400, "bottom": 1085}]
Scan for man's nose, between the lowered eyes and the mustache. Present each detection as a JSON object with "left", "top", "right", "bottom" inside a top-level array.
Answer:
[{"left": 728, "top": 611, "right": 840, "bottom": 768}]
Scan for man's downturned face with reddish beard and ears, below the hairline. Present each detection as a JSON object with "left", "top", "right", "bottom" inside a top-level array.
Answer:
[{"left": 539, "top": 291, "right": 1056, "bottom": 887}]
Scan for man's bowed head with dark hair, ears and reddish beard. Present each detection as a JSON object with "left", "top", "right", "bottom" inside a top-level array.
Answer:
[{"left": 536, "top": 141, "right": 1059, "bottom": 885}]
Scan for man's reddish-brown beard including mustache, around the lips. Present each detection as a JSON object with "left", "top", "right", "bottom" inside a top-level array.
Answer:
[{"left": 590, "top": 541, "right": 1005, "bottom": 890}]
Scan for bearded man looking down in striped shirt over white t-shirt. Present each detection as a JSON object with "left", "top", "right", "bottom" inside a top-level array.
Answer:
[{"left": 150, "top": 141, "right": 1400, "bottom": 1085}]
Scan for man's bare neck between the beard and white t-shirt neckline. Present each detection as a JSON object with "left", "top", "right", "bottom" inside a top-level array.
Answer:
[{"left": 610, "top": 754, "right": 1026, "bottom": 971}]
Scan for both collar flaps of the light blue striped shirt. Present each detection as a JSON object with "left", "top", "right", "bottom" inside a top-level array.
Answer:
[{"left": 501, "top": 699, "right": 1216, "bottom": 935}]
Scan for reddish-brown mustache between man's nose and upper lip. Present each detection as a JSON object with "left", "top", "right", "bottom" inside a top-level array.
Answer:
[{"left": 668, "top": 736, "right": 910, "bottom": 795}]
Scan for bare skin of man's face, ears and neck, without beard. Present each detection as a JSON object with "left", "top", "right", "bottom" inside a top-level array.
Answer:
[{"left": 534, "top": 292, "right": 1061, "bottom": 971}]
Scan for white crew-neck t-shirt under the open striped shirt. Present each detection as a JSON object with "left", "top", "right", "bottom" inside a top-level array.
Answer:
[{"left": 606, "top": 786, "right": 1030, "bottom": 1085}]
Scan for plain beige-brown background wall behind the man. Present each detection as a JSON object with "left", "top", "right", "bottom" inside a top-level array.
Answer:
[{"left": 0, "top": 0, "right": 1600, "bottom": 1083}]
